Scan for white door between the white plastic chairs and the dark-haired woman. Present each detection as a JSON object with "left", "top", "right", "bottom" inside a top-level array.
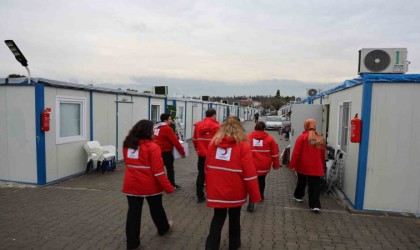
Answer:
[{"left": 117, "top": 102, "right": 133, "bottom": 160}]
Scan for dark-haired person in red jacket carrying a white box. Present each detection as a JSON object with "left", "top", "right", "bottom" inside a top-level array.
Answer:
[{"left": 153, "top": 113, "right": 185, "bottom": 189}]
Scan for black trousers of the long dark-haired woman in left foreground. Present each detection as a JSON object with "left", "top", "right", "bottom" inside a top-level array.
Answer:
[{"left": 125, "top": 194, "right": 169, "bottom": 249}]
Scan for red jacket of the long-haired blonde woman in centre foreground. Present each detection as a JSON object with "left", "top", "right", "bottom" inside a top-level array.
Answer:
[{"left": 205, "top": 137, "right": 261, "bottom": 208}]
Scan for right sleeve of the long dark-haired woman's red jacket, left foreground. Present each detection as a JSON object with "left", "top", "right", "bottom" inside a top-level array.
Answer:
[{"left": 149, "top": 146, "right": 174, "bottom": 194}]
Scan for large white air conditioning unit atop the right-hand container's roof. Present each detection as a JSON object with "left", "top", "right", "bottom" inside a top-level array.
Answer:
[{"left": 358, "top": 48, "right": 408, "bottom": 74}]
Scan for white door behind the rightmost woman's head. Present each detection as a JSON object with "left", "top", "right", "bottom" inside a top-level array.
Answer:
[{"left": 290, "top": 104, "right": 323, "bottom": 159}]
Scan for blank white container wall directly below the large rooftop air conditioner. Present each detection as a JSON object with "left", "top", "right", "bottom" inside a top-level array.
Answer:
[{"left": 364, "top": 83, "right": 420, "bottom": 213}]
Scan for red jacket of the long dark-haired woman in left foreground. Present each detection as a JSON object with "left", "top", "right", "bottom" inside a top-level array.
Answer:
[{"left": 122, "top": 140, "right": 174, "bottom": 196}]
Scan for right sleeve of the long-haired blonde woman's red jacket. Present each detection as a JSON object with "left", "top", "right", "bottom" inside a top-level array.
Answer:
[{"left": 241, "top": 142, "right": 262, "bottom": 202}]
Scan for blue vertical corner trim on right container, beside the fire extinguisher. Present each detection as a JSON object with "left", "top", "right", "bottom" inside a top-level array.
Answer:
[{"left": 355, "top": 75, "right": 373, "bottom": 210}]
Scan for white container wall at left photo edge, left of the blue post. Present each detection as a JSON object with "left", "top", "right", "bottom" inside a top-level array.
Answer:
[{"left": 0, "top": 86, "right": 37, "bottom": 183}]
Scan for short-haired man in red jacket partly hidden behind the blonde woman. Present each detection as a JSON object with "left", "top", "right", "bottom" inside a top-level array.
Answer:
[{"left": 193, "top": 108, "right": 220, "bottom": 203}]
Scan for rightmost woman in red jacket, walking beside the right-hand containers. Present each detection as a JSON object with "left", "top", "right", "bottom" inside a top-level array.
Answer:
[{"left": 289, "top": 119, "right": 325, "bottom": 213}]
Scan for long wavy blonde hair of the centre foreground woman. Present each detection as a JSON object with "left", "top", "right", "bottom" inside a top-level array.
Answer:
[{"left": 210, "top": 116, "right": 248, "bottom": 146}]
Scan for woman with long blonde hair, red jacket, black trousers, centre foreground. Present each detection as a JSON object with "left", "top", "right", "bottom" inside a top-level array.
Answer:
[{"left": 205, "top": 117, "right": 261, "bottom": 249}]
